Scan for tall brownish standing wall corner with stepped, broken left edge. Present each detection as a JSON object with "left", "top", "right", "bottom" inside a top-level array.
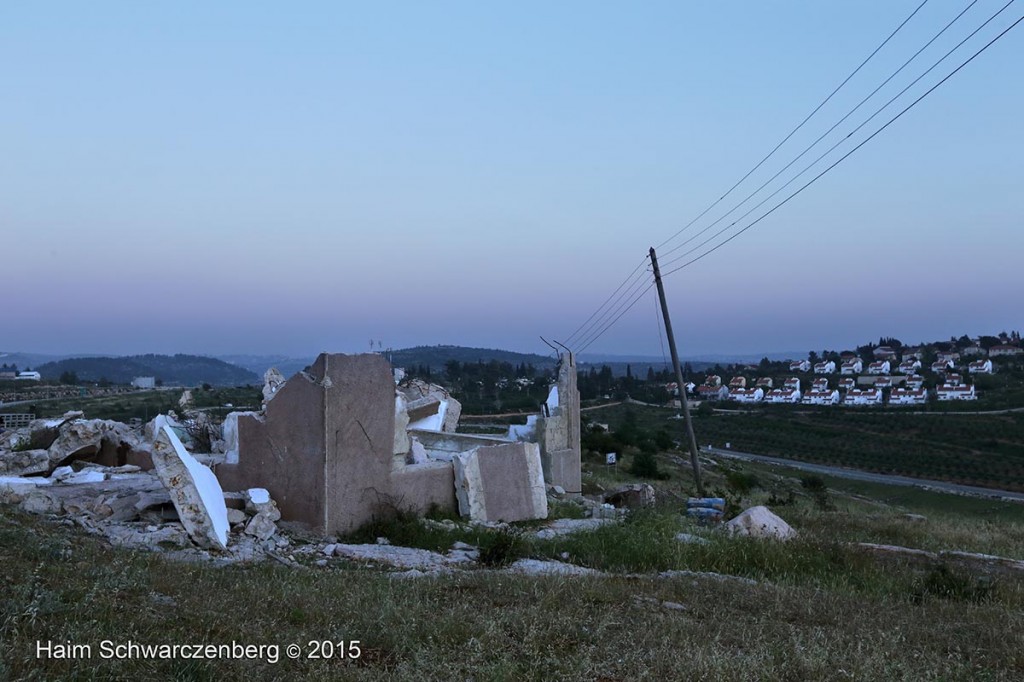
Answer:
[{"left": 217, "top": 353, "right": 395, "bottom": 534}]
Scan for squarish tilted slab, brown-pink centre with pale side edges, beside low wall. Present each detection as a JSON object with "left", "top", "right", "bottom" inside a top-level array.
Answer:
[{"left": 454, "top": 442, "right": 548, "bottom": 522}]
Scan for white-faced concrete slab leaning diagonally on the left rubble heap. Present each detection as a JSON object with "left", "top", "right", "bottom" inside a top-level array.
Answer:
[{"left": 153, "top": 411, "right": 228, "bottom": 550}]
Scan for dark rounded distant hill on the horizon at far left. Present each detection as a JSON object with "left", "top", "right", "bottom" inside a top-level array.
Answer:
[{"left": 36, "top": 354, "right": 262, "bottom": 386}]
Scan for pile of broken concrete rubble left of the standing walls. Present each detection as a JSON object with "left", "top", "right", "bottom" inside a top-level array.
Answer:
[{"left": 0, "top": 413, "right": 289, "bottom": 562}]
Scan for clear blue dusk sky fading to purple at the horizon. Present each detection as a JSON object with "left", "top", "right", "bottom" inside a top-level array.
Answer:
[{"left": 0, "top": 0, "right": 1024, "bottom": 356}]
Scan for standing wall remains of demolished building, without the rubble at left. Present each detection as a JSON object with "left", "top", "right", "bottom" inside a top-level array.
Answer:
[{"left": 215, "top": 353, "right": 581, "bottom": 534}]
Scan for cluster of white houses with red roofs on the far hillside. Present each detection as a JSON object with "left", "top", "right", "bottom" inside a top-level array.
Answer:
[{"left": 695, "top": 337, "right": 1024, "bottom": 406}]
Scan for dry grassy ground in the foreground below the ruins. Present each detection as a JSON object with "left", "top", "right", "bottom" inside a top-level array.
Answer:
[{"left": 0, "top": 444, "right": 1024, "bottom": 681}]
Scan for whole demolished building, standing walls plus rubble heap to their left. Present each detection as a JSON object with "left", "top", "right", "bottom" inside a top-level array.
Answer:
[{"left": 0, "top": 353, "right": 581, "bottom": 553}]
